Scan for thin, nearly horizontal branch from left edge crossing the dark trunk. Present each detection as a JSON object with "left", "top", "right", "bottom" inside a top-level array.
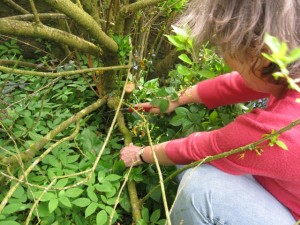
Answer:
[{"left": 0, "top": 65, "right": 131, "bottom": 78}]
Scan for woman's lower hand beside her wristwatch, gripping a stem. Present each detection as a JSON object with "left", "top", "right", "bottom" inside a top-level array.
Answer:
[{"left": 120, "top": 143, "right": 143, "bottom": 167}]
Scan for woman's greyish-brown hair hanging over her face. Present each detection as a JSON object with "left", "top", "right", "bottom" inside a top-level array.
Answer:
[{"left": 179, "top": 0, "right": 300, "bottom": 82}]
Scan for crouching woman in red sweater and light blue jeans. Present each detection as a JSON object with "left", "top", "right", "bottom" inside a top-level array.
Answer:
[{"left": 121, "top": 0, "right": 300, "bottom": 225}]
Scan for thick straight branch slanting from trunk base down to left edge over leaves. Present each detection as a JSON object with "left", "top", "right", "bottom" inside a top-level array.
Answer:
[{"left": 0, "top": 97, "right": 107, "bottom": 165}]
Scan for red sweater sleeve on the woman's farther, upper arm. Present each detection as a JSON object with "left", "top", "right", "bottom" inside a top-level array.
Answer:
[{"left": 197, "top": 72, "right": 268, "bottom": 108}]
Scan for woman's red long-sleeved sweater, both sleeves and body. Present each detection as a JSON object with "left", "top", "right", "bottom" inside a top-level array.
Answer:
[{"left": 166, "top": 72, "right": 300, "bottom": 220}]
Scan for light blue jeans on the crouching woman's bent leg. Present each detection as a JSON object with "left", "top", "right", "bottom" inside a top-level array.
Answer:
[{"left": 171, "top": 165, "right": 296, "bottom": 225}]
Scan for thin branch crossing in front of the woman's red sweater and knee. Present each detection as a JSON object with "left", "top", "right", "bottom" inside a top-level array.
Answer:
[{"left": 141, "top": 119, "right": 300, "bottom": 204}]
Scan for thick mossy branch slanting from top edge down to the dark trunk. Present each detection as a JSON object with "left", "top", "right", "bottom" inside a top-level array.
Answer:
[{"left": 45, "top": 0, "right": 118, "bottom": 53}]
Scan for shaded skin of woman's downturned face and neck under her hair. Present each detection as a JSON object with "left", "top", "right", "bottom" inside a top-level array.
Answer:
[{"left": 223, "top": 54, "right": 283, "bottom": 96}]
